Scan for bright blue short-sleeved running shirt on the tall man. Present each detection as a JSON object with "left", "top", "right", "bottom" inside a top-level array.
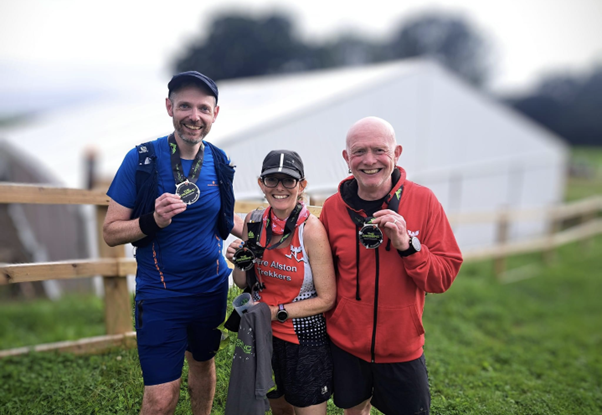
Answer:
[{"left": 107, "top": 137, "right": 230, "bottom": 299}]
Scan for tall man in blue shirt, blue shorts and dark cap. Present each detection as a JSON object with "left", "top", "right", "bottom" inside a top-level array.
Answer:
[{"left": 103, "top": 71, "right": 242, "bottom": 414}]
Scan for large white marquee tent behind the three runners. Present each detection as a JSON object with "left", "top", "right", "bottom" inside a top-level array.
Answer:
[{"left": 0, "top": 60, "right": 567, "bottom": 252}]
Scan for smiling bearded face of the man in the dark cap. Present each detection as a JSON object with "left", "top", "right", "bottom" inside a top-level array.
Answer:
[{"left": 165, "top": 85, "right": 219, "bottom": 145}]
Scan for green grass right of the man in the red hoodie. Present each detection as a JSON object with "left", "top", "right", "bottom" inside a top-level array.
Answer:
[{"left": 424, "top": 242, "right": 602, "bottom": 414}]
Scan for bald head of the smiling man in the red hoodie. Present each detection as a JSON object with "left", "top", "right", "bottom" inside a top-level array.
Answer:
[{"left": 343, "top": 117, "right": 402, "bottom": 200}]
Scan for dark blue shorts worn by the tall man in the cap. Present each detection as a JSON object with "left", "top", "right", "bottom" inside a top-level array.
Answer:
[{"left": 135, "top": 283, "right": 228, "bottom": 386}]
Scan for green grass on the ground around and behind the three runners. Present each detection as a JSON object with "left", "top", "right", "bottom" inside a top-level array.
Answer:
[{"left": 0, "top": 237, "right": 602, "bottom": 415}]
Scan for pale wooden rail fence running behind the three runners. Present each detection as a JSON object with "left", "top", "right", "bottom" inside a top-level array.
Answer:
[{"left": 0, "top": 183, "right": 602, "bottom": 358}]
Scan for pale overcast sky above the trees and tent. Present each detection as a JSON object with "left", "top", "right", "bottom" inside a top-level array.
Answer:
[{"left": 0, "top": 0, "right": 602, "bottom": 97}]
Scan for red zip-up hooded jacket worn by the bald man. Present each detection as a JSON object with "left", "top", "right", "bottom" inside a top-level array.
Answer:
[{"left": 320, "top": 167, "right": 462, "bottom": 363}]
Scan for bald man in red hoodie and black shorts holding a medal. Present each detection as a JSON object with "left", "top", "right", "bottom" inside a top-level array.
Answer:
[{"left": 320, "top": 117, "right": 462, "bottom": 415}]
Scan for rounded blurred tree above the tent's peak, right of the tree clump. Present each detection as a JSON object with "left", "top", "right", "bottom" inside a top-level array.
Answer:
[{"left": 387, "top": 13, "right": 489, "bottom": 86}]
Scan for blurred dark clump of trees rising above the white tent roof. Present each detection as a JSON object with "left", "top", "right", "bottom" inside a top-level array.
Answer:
[{"left": 175, "top": 14, "right": 488, "bottom": 85}]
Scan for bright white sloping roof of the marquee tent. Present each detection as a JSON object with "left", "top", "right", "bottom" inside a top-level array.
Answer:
[{"left": 0, "top": 60, "right": 558, "bottom": 195}]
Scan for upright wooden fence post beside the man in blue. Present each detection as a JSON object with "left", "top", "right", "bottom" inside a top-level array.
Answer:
[{"left": 96, "top": 206, "right": 134, "bottom": 334}]
